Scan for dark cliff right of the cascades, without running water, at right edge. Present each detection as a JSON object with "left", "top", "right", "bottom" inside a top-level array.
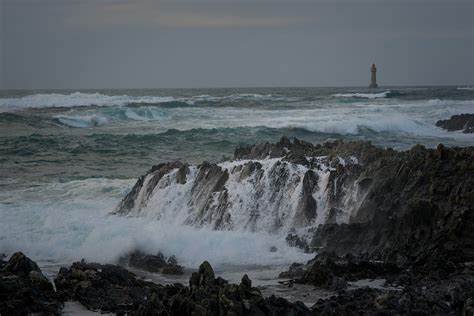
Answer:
[{"left": 312, "top": 145, "right": 474, "bottom": 270}]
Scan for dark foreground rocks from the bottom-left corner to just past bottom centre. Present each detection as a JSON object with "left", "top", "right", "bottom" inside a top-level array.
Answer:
[{"left": 0, "top": 252, "right": 311, "bottom": 315}]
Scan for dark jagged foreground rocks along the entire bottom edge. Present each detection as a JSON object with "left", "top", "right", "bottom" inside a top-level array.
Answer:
[{"left": 0, "top": 253, "right": 474, "bottom": 315}]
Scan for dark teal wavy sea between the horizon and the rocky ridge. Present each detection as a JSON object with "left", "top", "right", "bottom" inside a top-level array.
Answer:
[{"left": 0, "top": 87, "right": 474, "bottom": 181}]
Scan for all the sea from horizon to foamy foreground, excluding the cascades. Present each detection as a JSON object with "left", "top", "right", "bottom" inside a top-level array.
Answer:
[{"left": 0, "top": 87, "right": 474, "bottom": 282}]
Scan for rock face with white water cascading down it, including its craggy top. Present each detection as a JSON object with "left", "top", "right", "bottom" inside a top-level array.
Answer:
[{"left": 114, "top": 137, "right": 362, "bottom": 233}]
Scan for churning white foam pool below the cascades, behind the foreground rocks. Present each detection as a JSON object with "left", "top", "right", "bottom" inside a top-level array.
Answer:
[{"left": 0, "top": 179, "right": 310, "bottom": 268}]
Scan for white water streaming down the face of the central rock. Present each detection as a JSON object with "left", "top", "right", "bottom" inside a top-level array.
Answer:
[{"left": 126, "top": 157, "right": 357, "bottom": 236}]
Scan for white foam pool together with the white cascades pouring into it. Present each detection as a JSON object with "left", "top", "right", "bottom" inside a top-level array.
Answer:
[{"left": 0, "top": 157, "right": 356, "bottom": 267}]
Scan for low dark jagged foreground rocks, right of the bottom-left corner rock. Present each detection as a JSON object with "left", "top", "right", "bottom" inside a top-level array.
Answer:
[{"left": 55, "top": 262, "right": 311, "bottom": 315}]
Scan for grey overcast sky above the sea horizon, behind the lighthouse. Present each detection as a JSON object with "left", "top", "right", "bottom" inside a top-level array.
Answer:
[{"left": 0, "top": 0, "right": 474, "bottom": 89}]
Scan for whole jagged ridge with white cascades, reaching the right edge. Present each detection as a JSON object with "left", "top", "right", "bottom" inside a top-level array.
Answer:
[{"left": 114, "top": 138, "right": 474, "bottom": 270}]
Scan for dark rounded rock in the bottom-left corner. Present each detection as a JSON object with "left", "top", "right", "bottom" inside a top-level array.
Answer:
[{"left": 0, "top": 252, "right": 62, "bottom": 315}]
